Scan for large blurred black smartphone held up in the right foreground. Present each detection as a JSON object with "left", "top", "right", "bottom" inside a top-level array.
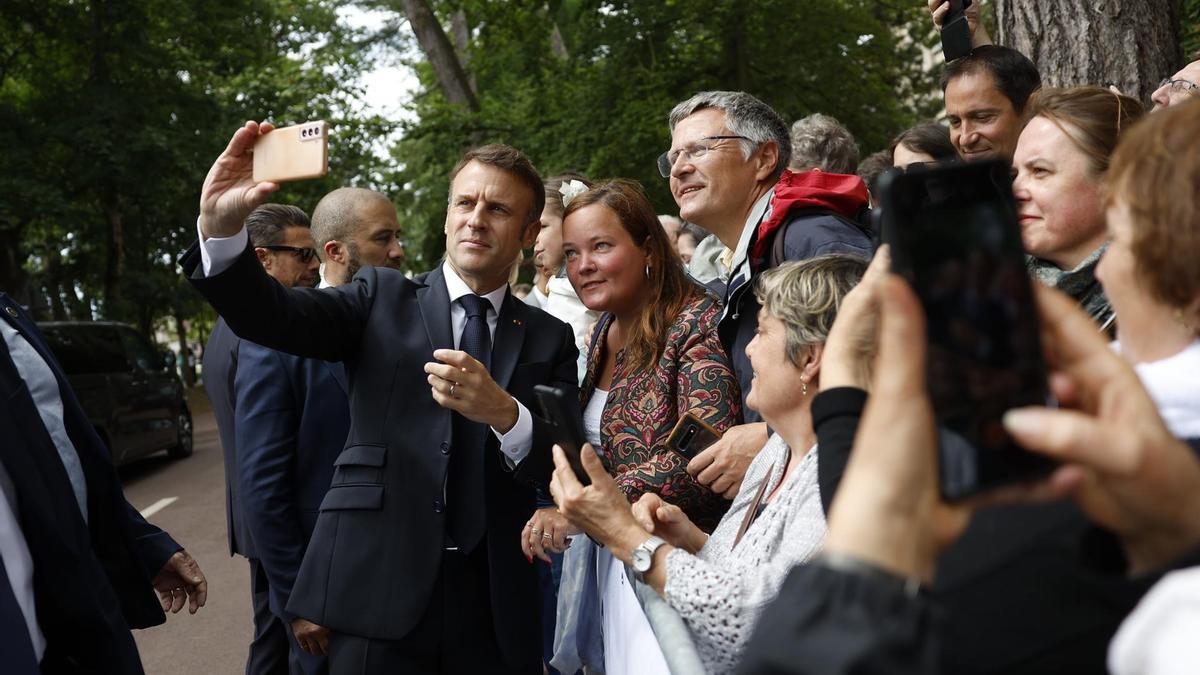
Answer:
[{"left": 880, "top": 161, "right": 1054, "bottom": 500}]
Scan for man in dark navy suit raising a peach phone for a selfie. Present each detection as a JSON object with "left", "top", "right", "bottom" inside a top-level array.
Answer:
[{"left": 182, "top": 123, "right": 577, "bottom": 674}]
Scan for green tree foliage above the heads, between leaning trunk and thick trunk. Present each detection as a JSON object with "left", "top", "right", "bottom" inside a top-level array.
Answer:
[{"left": 379, "top": 0, "right": 937, "bottom": 264}]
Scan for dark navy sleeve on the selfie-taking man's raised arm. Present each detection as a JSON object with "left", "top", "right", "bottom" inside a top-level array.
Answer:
[{"left": 180, "top": 243, "right": 369, "bottom": 362}]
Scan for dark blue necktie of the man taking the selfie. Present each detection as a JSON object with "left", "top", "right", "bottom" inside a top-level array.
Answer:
[{"left": 448, "top": 294, "right": 492, "bottom": 552}]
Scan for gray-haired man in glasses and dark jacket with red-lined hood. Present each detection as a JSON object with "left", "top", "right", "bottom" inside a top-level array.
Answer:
[{"left": 659, "top": 91, "right": 874, "bottom": 498}]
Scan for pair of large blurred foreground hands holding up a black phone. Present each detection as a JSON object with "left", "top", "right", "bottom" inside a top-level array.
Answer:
[{"left": 826, "top": 276, "right": 1200, "bottom": 583}]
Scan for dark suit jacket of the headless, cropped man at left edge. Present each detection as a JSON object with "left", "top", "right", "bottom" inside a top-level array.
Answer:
[{"left": 0, "top": 293, "right": 181, "bottom": 673}]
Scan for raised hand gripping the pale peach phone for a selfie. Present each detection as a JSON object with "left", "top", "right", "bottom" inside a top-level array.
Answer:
[{"left": 200, "top": 121, "right": 280, "bottom": 237}]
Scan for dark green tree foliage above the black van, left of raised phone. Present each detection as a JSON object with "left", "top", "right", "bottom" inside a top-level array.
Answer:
[{"left": 0, "top": 0, "right": 389, "bottom": 329}]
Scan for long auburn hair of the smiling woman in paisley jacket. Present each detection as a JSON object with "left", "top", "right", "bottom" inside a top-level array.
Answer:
[{"left": 563, "top": 179, "right": 703, "bottom": 368}]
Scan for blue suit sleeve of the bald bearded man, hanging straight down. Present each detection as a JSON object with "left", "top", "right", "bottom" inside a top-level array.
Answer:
[{"left": 234, "top": 341, "right": 305, "bottom": 620}]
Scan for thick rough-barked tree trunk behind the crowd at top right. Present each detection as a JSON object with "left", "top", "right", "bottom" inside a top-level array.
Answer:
[{"left": 994, "top": 0, "right": 1181, "bottom": 101}]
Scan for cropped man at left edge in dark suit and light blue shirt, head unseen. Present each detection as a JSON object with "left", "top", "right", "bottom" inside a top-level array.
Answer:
[{"left": 0, "top": 293, "right": 208, "bottom": 675}]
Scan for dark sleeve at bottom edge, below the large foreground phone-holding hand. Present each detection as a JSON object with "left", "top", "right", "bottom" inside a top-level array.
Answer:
[{"left": 738, "top": 563, "right": 938, "bottom": 675}]
